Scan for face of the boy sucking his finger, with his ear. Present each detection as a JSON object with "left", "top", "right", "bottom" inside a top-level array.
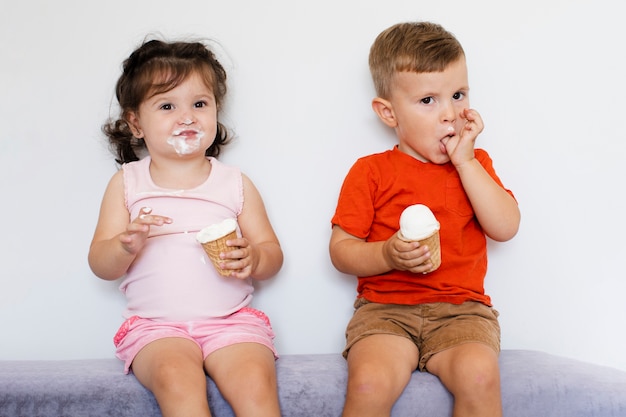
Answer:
[{"left": 372, "top": 58, "right": 469, "bottom": 164}]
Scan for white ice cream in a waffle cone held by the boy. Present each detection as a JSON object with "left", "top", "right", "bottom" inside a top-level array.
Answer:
[{"left": 398, "top": 204, "right": 441, "bottom": 273}]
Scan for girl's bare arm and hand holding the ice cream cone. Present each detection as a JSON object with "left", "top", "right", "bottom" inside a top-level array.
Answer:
[{"left": 224, "top": 175, "right": 283, "bottom": 280}]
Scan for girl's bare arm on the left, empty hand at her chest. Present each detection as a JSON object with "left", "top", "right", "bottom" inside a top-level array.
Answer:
[{"left": 88, "top": 171, "right": 171, "bottom": 281}]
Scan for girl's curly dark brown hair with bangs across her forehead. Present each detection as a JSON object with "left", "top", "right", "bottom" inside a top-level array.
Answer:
[{"left": 102, "top": 39, "right": 230, "bottom": 164}]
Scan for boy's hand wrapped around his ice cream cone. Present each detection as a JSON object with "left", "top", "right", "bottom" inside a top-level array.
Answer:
[{"left": 383, "top": 233, "right": 433, "bottom": 274}]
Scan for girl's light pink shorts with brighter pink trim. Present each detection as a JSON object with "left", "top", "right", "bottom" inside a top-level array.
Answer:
[{"left": 113, "top": 307, "right": 278, "bottom": 373}]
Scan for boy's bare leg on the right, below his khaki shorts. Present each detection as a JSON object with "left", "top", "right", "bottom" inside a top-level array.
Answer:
[{"left": 426, "top": 343, "right": 502, "bottom": 417}]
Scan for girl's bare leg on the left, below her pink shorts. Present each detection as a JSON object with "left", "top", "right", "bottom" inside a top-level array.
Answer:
[{"left": 132, "top": 337, "right": 211, "bottom": 417}]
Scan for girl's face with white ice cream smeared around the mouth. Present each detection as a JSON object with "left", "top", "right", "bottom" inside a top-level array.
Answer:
[{"left": 129, "top": 73, "right": 217, "bottom": 158}]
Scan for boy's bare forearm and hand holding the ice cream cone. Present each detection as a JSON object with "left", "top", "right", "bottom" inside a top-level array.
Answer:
[{"left": 329, "top": 225, "right": 432, "bottom": 277}]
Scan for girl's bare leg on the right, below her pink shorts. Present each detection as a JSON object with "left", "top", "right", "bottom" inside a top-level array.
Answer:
[{"left": 205, "top": 343, "right": 280, "bottom": 417}]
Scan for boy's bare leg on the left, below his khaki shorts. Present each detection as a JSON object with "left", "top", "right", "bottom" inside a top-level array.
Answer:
[{"left": 342, "top": 335, "right": 418, "bottom": 417}]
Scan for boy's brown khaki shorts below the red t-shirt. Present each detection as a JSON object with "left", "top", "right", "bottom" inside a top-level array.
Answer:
[{"left": 343, "top": 298, "right": 500, "bottom": 371}]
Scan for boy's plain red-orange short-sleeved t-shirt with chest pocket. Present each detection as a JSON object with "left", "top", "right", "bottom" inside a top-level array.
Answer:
[{"left": 332, "top": 147, "right": 513, "bottom": 306}]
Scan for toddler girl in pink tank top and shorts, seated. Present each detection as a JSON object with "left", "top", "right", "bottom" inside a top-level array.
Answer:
[{"left": 89, "top": 40, "right": 283, "bottom": 417}]
